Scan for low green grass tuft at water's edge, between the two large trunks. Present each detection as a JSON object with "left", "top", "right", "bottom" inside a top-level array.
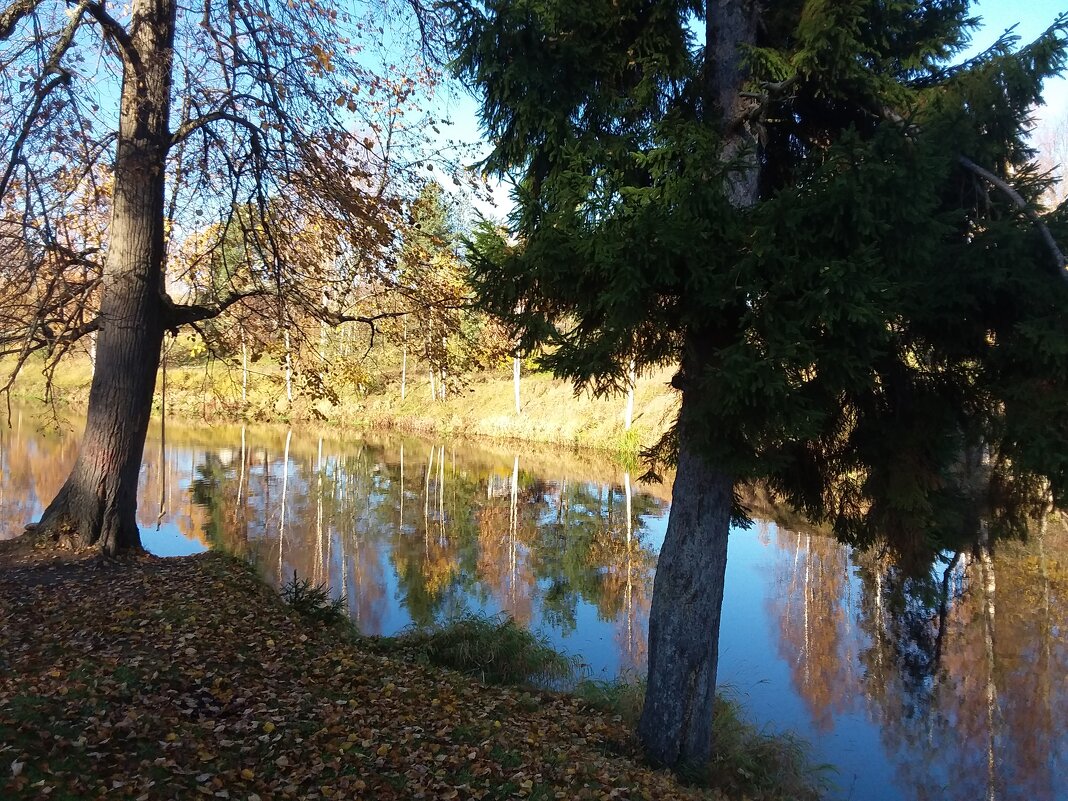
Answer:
[{"left": 390, "top": 614, "right": 578, "bottom": 685}]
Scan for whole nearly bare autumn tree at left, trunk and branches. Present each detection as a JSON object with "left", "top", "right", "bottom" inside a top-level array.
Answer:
[{"left": 0, "top": 0, "right": 446, "bottom": 553}]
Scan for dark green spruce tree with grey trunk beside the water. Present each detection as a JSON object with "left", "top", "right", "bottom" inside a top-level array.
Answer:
[{"left": 452, "top": 0, "right": 1068, "bottom": 767}]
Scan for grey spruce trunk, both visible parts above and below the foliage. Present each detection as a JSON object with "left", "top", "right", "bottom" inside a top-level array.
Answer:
[{"left": 638, "top": 0, "right": 760, "bottom": 770}]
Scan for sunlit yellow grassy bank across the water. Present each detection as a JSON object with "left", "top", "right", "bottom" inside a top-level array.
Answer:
[{"left": 0, "top": 356, "right": 678, "bottom": 458}]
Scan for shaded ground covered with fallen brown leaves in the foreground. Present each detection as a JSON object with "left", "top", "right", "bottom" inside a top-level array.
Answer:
[{"left": 0, "top": 550, "right": 711, "bottom": 801}]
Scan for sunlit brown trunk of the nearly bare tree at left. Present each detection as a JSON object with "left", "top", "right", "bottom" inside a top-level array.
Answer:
[{"left": 37, "top": 0, "right": 176, "bottom": 554}]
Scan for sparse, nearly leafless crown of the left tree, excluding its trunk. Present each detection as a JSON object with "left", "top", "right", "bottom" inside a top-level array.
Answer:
[{"left": 0, "top": 0, "right": 447, "bottom": 382}]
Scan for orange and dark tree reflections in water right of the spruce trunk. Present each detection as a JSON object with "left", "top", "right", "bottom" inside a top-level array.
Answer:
[{"left": 769, "top": 520, "right": 1068, "bottom": 801}]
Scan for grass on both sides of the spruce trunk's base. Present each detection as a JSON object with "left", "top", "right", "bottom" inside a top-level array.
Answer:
[{"left": 575, "top": 680, "right": 830, "bottom": 801}]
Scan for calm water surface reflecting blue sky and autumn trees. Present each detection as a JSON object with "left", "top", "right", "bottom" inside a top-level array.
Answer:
[{"left": 0, "top": 419, "right": 1068, "bottom": 801}]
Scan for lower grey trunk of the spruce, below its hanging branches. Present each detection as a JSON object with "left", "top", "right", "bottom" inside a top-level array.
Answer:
[{"left": 638, "top": 380, "right": 734, "bottom": 768}]
